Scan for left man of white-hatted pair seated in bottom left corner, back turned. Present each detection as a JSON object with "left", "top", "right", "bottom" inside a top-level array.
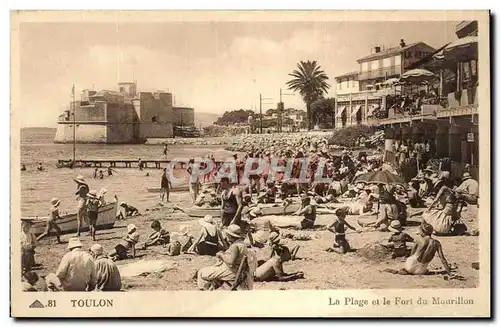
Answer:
[{"left": 56, "top": 237, "right": 97, "bottom": 292}]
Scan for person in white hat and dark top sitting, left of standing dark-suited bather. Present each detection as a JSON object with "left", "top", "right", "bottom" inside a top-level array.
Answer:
[{"left": 187, "top": 215, "right": 222, "bottom": 256}]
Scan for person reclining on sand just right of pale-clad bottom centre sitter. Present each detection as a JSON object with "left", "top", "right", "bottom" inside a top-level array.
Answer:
[{"left": 254, "top": 238, "right": 304, "bottom": 282}]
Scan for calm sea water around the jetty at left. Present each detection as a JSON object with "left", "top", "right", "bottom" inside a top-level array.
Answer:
[{"left": 20, "top": 128, "right": 231, "bottom": 217}]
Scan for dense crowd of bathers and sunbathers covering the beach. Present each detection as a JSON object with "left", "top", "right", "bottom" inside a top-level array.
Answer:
[{"left": 21, "top": 135, "right": 479, "bottom": 291}]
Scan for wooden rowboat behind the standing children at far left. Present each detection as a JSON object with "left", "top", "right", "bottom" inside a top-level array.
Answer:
[{"left": 22, "top": 202, "right": 117, "bottom": 235}]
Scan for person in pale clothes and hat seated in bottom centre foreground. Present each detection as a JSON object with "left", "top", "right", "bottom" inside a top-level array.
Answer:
[{"left": 195, "top": 224, "right": 253, "bottom": 290}]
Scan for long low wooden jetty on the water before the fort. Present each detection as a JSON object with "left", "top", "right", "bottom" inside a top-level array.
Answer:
[{"left": 57, "top": 159, "right": 221, "bottom": 169}]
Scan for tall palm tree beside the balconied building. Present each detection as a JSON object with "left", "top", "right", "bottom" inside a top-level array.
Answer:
[{"left": 286, "top": 60, "right": 330, "bottom": 130}]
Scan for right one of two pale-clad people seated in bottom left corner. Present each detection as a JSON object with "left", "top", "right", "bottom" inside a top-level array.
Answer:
[{"left": 90, "top": 244, "right": 122, "bottom": 292}]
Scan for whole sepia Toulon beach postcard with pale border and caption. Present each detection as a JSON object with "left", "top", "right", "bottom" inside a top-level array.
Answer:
[{"left": 10, "top": 11, "right": 491, "bottom": 318}]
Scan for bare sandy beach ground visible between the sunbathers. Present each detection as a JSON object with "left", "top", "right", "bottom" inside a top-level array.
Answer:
[{"left": 31, "top": 188, "right": 479, "bottom": 291}]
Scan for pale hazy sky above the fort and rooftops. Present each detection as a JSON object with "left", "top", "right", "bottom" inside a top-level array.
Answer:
[{"left": 18, "top": 21, "right": 457, "bottom": 127}]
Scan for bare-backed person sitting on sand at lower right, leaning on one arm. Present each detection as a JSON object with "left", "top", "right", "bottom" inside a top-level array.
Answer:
[{"left": 384, "top": 222, "right": 451, "bottom": 275}]
